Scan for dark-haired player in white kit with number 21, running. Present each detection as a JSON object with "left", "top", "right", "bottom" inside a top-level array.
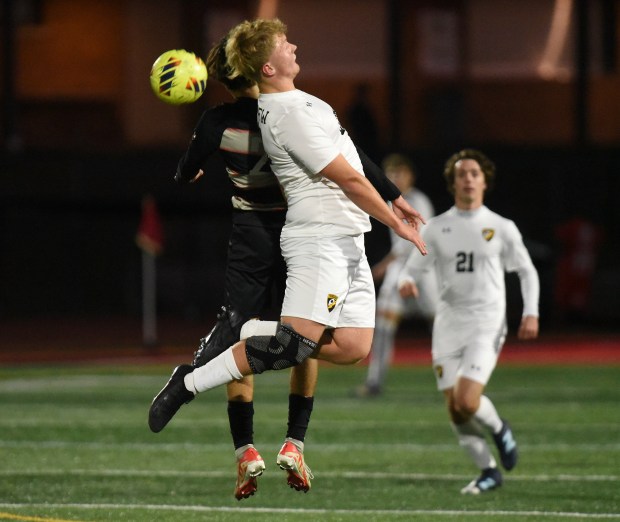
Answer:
[{"left": 399, "top": 149, "right": 540, "bottom": 494}]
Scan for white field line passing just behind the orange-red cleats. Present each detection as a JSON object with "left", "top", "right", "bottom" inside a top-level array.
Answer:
[{"left": 0, "top": 469, "right": 620, "bottom": 482}]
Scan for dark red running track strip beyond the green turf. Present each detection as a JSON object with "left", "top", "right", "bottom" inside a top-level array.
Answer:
[{"left": 0, "top": 318, "right": 620, "bottom": 366}]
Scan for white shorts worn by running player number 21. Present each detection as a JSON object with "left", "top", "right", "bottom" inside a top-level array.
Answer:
[{"left": 433, "top": 306, "right": 507, "bottom": 390}]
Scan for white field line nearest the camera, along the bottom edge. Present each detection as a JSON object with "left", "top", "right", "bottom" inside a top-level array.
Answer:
[{"left": 0, "top": 503, "right": 620, "bottom": 520}]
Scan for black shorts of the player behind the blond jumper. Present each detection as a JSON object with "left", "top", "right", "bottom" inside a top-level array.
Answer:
[{"left": 225, "top": 210, "right": 286, "bottom": 319}]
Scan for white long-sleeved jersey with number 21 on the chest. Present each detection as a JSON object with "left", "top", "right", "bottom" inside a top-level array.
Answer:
[{"left": 401, "top": 206, "right": 540, "bottom": 325}]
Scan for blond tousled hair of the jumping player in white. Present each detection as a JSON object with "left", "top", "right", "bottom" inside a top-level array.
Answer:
[{"left": 226, "top": 18, "right": 287, "bottom": 82}]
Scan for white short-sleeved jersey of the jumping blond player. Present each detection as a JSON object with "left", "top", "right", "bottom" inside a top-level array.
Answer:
[{"left": 258, "top": 90, "right": 370, "bottom": 238}]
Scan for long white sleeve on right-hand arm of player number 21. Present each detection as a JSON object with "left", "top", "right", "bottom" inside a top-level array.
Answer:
[{"left": 504, "top": 221, "right": 540, "bottom": 317}]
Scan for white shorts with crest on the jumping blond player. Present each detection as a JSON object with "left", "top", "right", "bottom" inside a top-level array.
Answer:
[{"left": 280, "top": 235, "right": 375, "bottom": 328}]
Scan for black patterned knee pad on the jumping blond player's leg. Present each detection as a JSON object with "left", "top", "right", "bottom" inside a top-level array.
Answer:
[{"left": 245, "top": 324, "right": 318, "bottom": 374}]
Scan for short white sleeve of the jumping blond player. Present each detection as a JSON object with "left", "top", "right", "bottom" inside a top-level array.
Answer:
[{"left": 278, "top": 107, "right": 340, "bottom": 174}]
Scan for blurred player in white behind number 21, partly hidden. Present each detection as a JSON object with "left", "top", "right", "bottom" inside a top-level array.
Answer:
[{"left": 356, "top": 154, "right": 437, "bottom": 397}]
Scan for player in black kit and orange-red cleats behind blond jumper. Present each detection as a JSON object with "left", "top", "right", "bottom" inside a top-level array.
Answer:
[{"left": 149, "top": 34, "right": 400, "bottom": 500}]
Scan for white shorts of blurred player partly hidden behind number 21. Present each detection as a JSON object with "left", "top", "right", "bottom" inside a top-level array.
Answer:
[{"left": 377, "top": 259, "right": 439, "bottom": 319}]
